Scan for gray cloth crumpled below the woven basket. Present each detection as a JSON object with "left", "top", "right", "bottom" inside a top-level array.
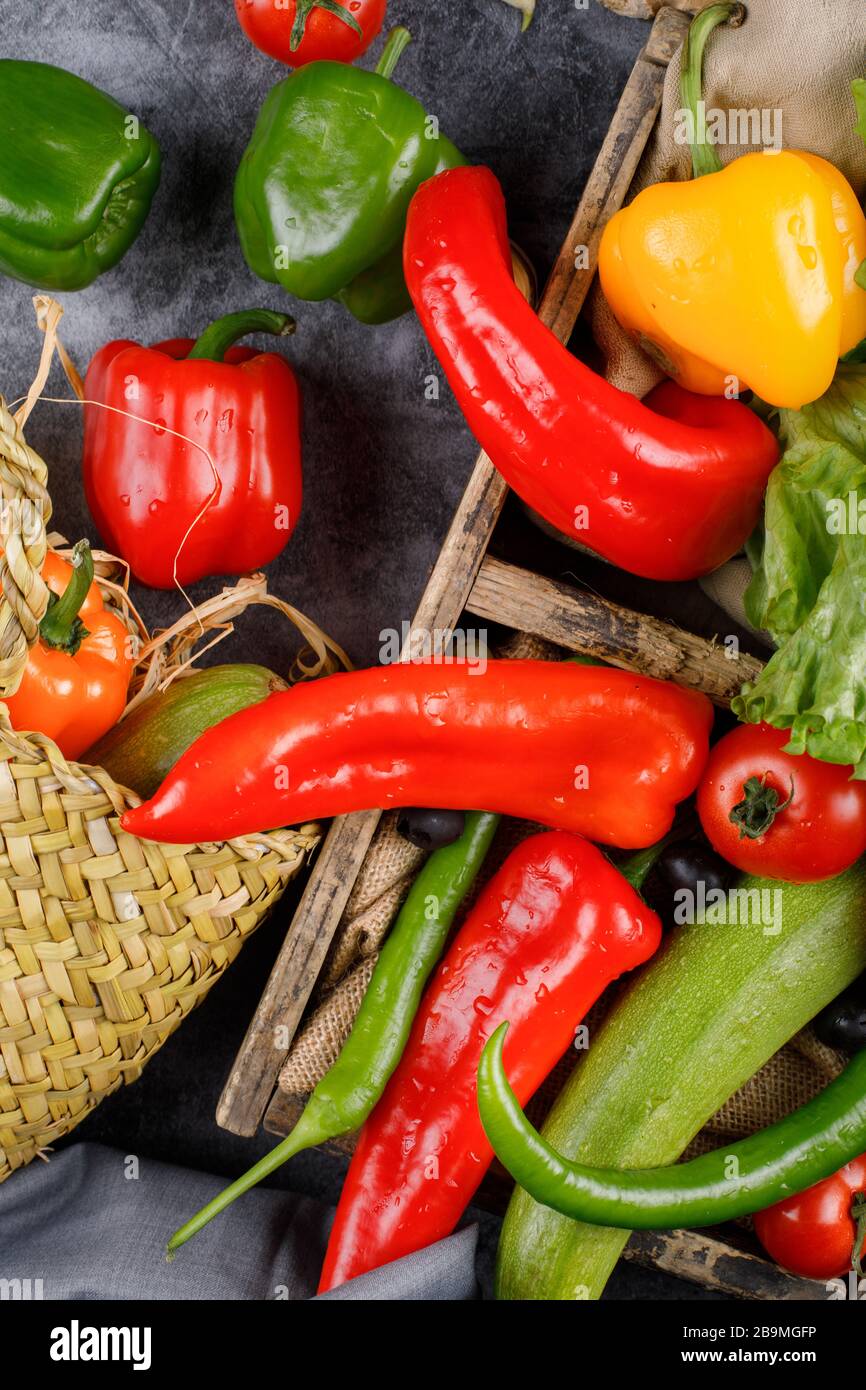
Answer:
[{"left": 0, "top": 1144, "right": 478, "bottom": 1302}]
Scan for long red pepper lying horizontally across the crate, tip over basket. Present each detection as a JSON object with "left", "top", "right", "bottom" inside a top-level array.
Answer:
[{"left": 122, "top": 660, "right": 713, "bottom": 849}]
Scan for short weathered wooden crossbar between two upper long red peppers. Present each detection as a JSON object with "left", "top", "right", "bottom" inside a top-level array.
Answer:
[{"left": 466, "top": 555, "right": 762, "bottom": 708}]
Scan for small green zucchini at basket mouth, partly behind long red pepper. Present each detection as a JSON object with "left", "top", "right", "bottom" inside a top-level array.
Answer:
[{"left": 81, "top": 664, "right": 286, "bottom": 798}]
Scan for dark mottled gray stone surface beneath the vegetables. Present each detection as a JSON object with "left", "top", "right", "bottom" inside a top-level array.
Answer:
[{"left": 0, "top": 0, "right": 750, "bottom": 1298}]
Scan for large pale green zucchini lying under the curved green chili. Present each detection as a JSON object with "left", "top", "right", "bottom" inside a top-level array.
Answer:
[{"left": 496, "top": 862, "right": 866, "bottom": 1300}]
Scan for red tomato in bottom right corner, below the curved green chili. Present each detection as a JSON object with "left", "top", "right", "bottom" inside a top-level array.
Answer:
[{"left": 755, "top": 1154, "right": 866, "bottom": 1279}]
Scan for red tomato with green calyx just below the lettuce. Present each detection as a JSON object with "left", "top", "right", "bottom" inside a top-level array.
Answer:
[{"left": 698, "top": 724, "right": 866, "bottom": 883}]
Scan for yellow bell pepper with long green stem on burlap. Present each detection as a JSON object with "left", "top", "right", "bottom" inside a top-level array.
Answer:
[{"left": 599, "top": 6, "right": 866, "bottom": 409}]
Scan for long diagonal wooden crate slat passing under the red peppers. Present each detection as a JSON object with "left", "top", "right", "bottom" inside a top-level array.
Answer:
[{"left": 217, "top": 10, "right": 687, "bottom": 1134}]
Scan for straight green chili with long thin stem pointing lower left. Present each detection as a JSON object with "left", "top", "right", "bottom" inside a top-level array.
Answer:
[{"left": 168, "top": 810, "right": 499, "bottom": 1254}]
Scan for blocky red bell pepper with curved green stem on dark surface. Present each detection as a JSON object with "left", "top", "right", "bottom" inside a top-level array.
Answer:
[{"left": 83, "top": 309, "right": 302, "bottom": 589}]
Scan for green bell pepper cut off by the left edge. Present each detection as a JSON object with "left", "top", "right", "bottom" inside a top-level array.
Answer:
[{"left": 0, "top": 58, "right": 160, "bottom": 291}]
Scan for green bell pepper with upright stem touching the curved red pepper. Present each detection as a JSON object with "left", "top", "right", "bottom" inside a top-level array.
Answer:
[{"left": 235, "top": 29, "right": 466, "bottom": 324}]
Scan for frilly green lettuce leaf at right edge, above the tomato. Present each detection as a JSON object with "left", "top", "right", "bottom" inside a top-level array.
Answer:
[{"left": 733, "top": 364, "right": 866, "bottom": 777}]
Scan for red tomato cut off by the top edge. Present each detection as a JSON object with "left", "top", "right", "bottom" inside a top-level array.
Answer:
[{"left": 235, "top": 0, "right": 386, "bottom": 68}]
